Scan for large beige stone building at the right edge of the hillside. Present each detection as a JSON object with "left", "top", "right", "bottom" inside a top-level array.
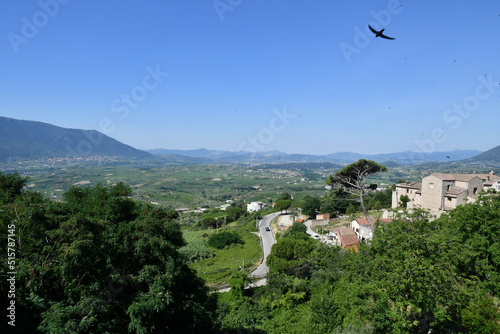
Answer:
[{"left": 392, "top": 172, "right": 500, "bottom": 217}]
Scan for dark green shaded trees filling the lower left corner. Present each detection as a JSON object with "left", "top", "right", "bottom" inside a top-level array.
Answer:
[{"left": 0, "top": 173, "right": 217, "bottom": 333}]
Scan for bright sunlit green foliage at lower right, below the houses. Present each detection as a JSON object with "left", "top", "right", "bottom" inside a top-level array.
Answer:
[{"left": 218, "top": 195, "right": 500, "bottom": 334}]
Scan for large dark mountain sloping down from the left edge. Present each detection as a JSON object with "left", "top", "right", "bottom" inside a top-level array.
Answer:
[{"left": 0, "top": 117, "right": 153, "bottom": 161}]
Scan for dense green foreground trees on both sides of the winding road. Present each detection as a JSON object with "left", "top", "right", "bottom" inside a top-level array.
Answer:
[{"left": 0, "top": 173, "right": 500, "bottom": 334}]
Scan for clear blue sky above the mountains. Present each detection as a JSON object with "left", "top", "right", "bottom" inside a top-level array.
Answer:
[{"left": 0, "top": 0, "right": 500, "bottom": 154}]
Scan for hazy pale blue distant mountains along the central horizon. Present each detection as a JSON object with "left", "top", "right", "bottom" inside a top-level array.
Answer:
[{"left": 148, "top": 148, "right": 481, "bottom": 167}]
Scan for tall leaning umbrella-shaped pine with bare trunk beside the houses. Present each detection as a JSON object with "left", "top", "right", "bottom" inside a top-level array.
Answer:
[{"left": 326, "top": 159, "right": 387, "bottom": 231}]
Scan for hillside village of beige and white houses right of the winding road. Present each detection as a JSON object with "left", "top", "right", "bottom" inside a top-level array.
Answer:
[{"left": 247, "top": 171, "right": 500, "bottom": 251}]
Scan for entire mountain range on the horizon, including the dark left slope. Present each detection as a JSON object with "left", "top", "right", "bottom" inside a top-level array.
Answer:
[{"left": 0, "top": 117, "right": 500, "bottom": 167}]
